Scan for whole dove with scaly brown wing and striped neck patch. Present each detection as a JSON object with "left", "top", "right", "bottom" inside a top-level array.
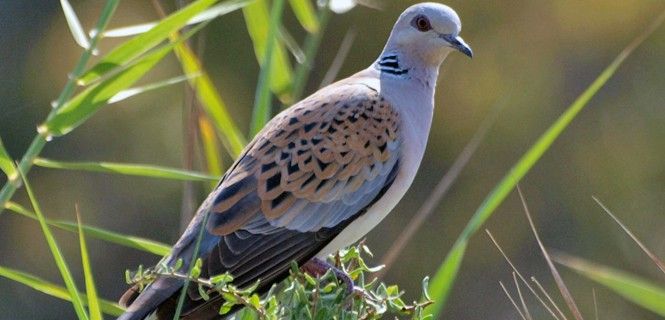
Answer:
[{"left": 118, "top": 2, "right": 473, "bottom": 320}]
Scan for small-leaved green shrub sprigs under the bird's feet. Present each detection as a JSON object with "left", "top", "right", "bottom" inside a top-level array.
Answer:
[{"left": 127, "top": 244, "right": 432, "bottom": 320}]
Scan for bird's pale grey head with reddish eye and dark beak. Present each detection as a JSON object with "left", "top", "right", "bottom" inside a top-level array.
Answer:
[{"left": 386, "top": 2, "right": 473, "bottom": 66}]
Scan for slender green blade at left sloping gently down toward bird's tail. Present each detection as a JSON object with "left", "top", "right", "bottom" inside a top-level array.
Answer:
[{"left": 5, "top": 202, "right": 171, "bottom": 256}]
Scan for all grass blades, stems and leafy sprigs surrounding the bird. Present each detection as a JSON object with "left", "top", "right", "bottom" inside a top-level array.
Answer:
[{"left": 0, "top": 0, "right": 665, "bottom": 319}]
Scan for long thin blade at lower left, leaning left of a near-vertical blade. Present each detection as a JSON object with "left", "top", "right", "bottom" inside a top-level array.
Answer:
[{"left": 19, "top": 171, "right": 88, "bottom": 319}]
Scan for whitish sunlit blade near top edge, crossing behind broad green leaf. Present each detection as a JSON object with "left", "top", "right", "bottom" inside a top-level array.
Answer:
[{"left": 102, "top": 0, "right": 254, "bottom": 38}]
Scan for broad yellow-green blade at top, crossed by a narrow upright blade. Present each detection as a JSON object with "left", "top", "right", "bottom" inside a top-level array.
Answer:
[{"left": 242, "top": 0, "right": 293, "bottom": 102}]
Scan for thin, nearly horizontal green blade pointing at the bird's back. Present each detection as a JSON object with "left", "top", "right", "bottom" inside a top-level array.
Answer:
[{"left": 35, "top": 158, "right": 220, "bottom": 182}]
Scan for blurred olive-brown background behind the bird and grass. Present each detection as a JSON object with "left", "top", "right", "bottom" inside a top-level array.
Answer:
[{"left": 0, "top": 0, "right": 665, "bottom": 320}]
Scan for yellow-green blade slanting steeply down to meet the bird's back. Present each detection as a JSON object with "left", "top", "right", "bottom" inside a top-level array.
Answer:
[{"left": 175, "top": 38, "right": 247, "bottom": 158}]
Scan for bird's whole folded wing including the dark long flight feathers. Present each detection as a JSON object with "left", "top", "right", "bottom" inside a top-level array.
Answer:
[{"left": 119, "top": 82, "right": 400, "bottom": 319}]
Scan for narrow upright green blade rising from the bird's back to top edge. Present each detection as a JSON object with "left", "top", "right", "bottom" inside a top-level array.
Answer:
[{"left": 249, "top": 0, "right": 284, "bottom": 137}]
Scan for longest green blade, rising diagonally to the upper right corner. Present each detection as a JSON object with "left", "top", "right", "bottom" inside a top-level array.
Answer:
[{"left": 426, "top": 12, "right": 665, "bottom": 318}]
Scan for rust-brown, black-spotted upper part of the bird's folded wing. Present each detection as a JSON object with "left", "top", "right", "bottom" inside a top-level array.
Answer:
[{"left": 208, "top": 80, "right": 400, "bottom": 236}]
